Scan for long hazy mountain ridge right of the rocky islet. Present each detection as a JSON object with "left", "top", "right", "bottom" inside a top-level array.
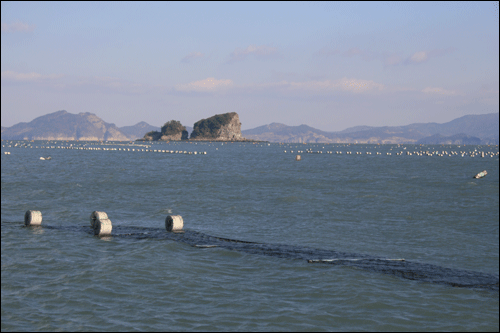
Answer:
[{"left": 242, "top": 113, "right": 499, "bottom": 144}]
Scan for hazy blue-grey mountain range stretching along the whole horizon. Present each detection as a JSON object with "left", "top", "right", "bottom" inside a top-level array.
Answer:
[{"left": 1, "top": 110, "right": 499, "bottom": 145}]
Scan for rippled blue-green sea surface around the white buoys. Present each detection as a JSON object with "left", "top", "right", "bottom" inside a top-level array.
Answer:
[{"left": 1, "top": 140, "right": 499, "bottom": 331}]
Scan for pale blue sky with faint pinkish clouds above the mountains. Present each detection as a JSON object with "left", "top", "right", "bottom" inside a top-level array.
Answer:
[{"left": 1, "top": 1, "right": 500, "bottom": 131}]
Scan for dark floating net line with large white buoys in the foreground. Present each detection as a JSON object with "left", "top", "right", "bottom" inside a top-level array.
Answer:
[{"left": 24, "top": 210, "right": 499, "bottom": 291}]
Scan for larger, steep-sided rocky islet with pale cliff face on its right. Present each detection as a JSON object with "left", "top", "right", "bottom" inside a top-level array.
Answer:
[{"left": 190, "top": 112, "right": 247, "bottom": 141}]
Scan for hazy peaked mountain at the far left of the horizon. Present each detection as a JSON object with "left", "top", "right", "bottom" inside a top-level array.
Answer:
[{"left": 2, "top": 110, "right": 130, "bottom": 141}]
